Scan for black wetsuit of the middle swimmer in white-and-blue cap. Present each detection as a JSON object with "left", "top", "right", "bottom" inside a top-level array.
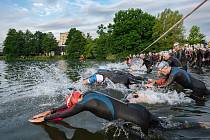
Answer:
[{"left": 96, "top": 70, "right": 147, "bottom": 88}]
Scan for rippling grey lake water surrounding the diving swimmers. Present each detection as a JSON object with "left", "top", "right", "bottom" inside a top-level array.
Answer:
[{"left": 0, "top": 60, "right": 210, "bottom": 140}]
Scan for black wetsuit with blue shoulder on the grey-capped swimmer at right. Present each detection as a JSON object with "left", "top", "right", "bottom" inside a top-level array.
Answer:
[{"left": 164, "top": 67, "right": 210, "bottom": 96}]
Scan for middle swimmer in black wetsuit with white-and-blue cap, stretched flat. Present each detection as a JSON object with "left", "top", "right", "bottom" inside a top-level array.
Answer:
[{"left": 83, "top": 70, "right": 146, "bottom": 88}]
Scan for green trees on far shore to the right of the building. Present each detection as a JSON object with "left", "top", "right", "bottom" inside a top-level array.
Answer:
[{"left": 66, "top": 9, "right": 205, "bottom": 59}]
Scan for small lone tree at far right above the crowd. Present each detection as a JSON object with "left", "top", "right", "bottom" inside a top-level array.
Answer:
[{"left": 187, "top": 25, "right": 205, "bottom": 45}]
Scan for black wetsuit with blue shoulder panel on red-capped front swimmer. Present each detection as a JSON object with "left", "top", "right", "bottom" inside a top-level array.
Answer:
[{"left": 45, "top": 92, "right": 159, "bottom": 134}]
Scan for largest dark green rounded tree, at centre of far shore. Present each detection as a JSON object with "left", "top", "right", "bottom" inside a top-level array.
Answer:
[{"left": 94, "top": 9, "right": 156, "bottom": 59}]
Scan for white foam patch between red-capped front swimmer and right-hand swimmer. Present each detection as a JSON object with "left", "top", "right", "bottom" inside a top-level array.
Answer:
[{"left": 127, "top": 89, "right": 193, "bottom": 105}]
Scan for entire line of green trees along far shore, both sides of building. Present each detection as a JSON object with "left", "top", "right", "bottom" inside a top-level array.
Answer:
[{"left": 4, "top": 9, "right": 205, "bottom": 60}]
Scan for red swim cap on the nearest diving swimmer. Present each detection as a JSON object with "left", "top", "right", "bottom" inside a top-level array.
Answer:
[{"left": 66, "top": 91, "right": 81, "bottom": 108}]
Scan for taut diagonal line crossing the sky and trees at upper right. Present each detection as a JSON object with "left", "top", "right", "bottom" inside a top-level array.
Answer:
[{"left": 140, "top": 0, "right": 208, "bottom": 53}]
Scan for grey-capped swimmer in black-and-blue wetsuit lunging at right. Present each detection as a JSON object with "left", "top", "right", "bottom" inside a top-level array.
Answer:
[{"left": 146, "top": 61, "right": 210, "bottom": 97}]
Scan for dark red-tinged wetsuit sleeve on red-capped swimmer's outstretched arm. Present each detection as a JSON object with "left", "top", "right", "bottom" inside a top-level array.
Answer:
[{"left": 44, "top": 104, "right": 83, "bottom": 121}]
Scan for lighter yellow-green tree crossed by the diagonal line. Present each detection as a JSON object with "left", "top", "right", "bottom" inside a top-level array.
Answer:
[{"left": 151, "top": 9, "right": 184, "bottom": 51}]
